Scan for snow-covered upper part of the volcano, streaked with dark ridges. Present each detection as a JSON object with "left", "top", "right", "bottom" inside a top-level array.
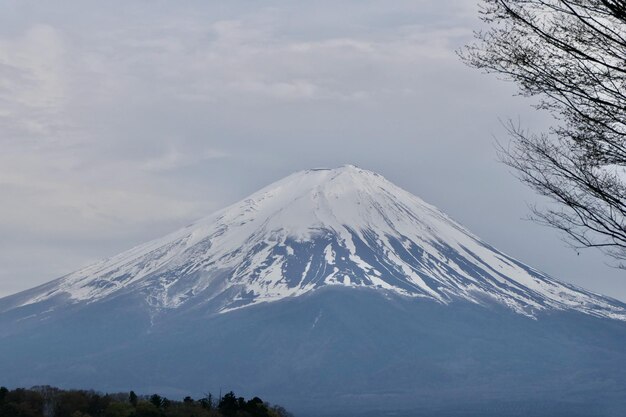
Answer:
[{"left": 8, "top": 166, "right": 626, "bottom": 320}]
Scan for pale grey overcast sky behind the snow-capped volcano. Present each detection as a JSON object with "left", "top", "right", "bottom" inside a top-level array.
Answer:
[{"left": 0, "top": 0, "right": 626, "bottom": 300}]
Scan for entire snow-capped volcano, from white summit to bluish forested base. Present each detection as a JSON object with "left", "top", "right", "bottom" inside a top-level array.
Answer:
[{"left": 0, "top": 166, "right": 626, "bottom": 417}]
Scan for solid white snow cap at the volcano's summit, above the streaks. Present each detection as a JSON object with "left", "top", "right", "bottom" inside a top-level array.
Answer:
[{"left": 189, "top": 165, "right": 444, "bottom": 245}]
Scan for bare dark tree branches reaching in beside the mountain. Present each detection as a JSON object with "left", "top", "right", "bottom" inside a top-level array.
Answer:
[{"left": 459, "top": 0, "right": 626, "bottom": 268}]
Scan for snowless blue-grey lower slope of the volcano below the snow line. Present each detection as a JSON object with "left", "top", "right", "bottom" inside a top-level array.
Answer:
[{"left": 0, "top": 286, "right": 626, "bottom": 417}]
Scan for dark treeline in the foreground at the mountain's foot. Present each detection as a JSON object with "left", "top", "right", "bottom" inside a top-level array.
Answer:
[{"left": 0, "top": 386, "right": 293, "bottom": 417}]
